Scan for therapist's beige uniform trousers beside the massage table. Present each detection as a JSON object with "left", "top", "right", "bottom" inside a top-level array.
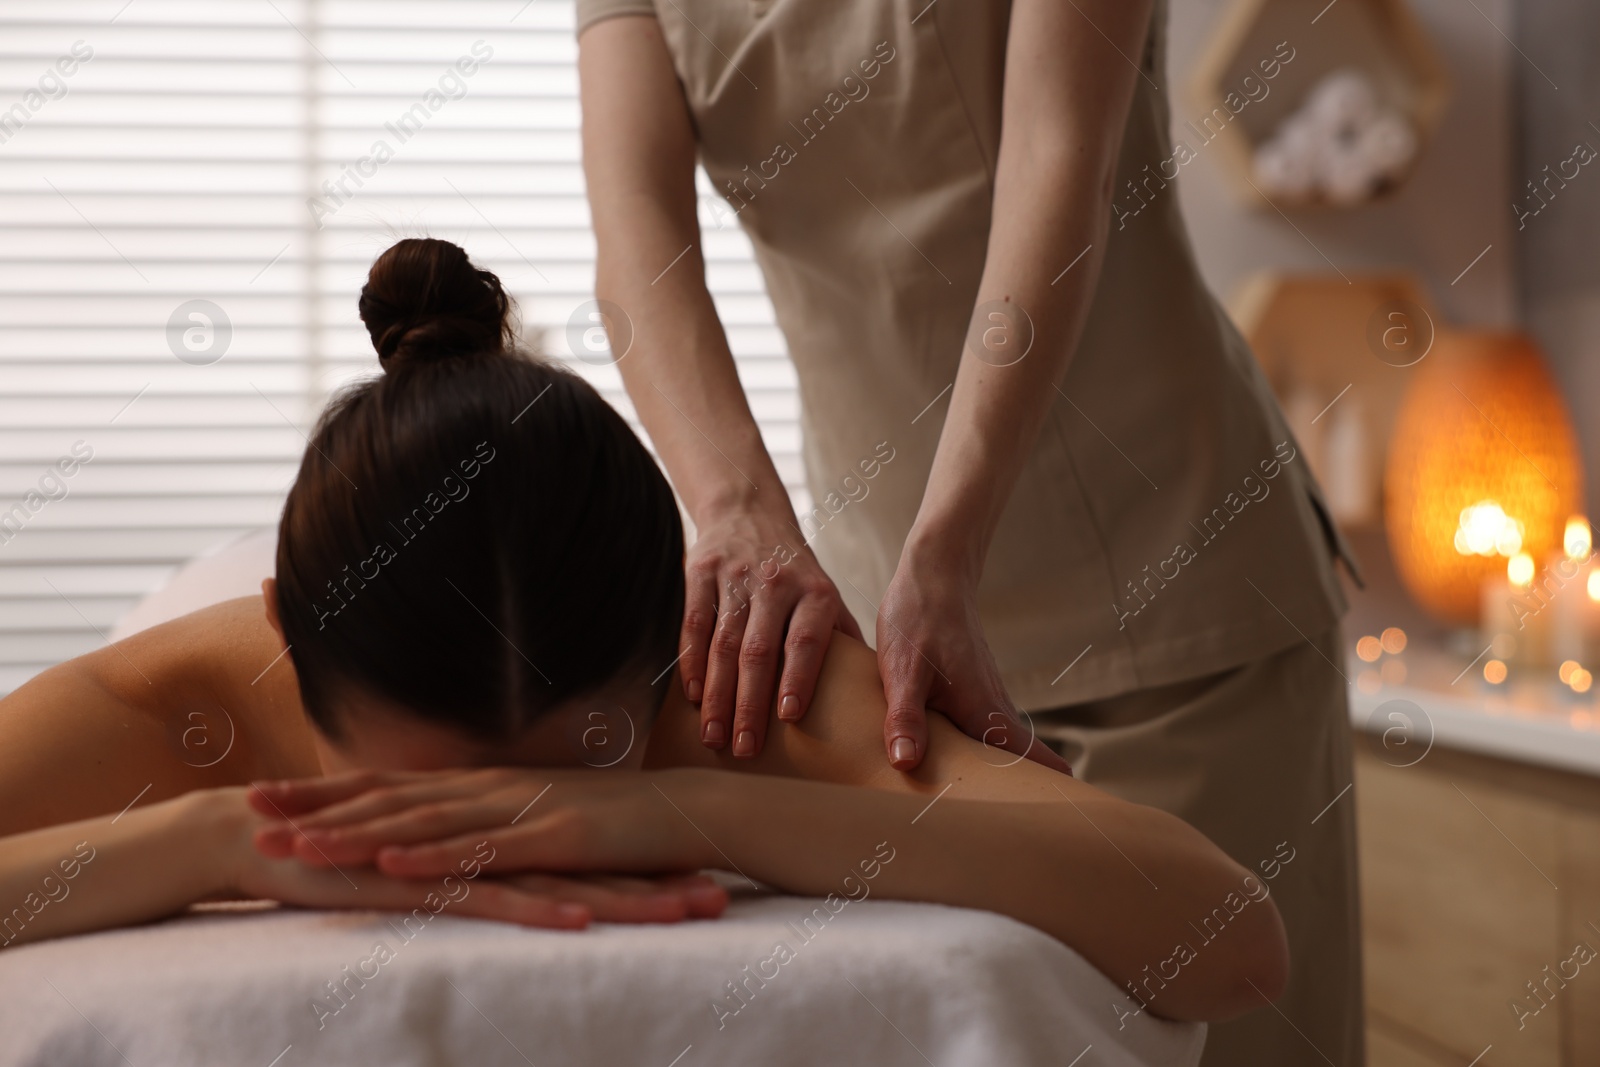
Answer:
[{"left": 1032, "top": 627, "right": 1365, "bottom": 1067}]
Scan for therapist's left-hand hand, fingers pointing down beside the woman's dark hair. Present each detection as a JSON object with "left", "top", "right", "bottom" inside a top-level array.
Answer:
[{"left": 678, "top": 509, "right": 861, "bottom": 757}]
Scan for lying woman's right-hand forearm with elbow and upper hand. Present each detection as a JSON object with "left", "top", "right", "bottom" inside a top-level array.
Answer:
[{"left": 258, "top": 763, "right": 1288, "bottom": 1019}]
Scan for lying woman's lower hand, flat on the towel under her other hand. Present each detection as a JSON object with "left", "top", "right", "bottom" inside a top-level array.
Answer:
[{"left": 224, "top": 779, "right": 726, "bottom": 929}]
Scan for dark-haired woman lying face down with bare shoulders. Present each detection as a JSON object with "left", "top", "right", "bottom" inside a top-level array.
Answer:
[{"left": 0, "top": 240, "right": 1288, "bottom": 1019}]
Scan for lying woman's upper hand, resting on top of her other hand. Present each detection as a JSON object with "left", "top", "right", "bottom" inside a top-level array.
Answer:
[{"left": 251, "top": 768, "right": 726, "bottom": 895}]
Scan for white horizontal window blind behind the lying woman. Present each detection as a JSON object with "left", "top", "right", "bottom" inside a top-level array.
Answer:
[{"left": 0, "top": 0, "right": 800, "bottom": 693}]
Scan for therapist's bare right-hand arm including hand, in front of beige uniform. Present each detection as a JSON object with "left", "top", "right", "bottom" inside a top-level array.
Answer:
[{"left": 877, "top": 0, "right": 1152, "bottom": 769}]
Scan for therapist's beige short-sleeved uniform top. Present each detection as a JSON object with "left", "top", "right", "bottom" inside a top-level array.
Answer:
[{"left": 578, "top": 0, "right": 1347, "bottom": 710}]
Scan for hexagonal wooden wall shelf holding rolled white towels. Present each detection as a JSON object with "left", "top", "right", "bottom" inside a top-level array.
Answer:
[{"left": 1178, "top": 0, "right": 1450, "bottom": 206}]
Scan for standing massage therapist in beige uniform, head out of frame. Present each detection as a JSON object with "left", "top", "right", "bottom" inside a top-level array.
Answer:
[{"left": 578, "top": 0, "right": 1363, "bottom": 1067}]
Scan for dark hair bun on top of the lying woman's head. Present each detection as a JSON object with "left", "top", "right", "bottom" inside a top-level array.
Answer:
[{"left": 360, "top": 237, "right": 515, "bottom": 370}]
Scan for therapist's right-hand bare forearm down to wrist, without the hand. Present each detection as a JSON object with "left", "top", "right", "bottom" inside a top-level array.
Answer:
[{"left": 907, "top": 0, "right": 1152, "bottom": 581}]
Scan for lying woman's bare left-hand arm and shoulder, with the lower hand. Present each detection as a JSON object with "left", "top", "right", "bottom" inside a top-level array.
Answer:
[{"left": 0, "top": 597, "right": 725, "bottom": 947}]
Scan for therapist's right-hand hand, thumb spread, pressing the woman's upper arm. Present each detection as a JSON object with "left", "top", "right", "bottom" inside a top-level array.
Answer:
[{"left": 878, "top": 552, "right": 1072, "bottom": 774}]
